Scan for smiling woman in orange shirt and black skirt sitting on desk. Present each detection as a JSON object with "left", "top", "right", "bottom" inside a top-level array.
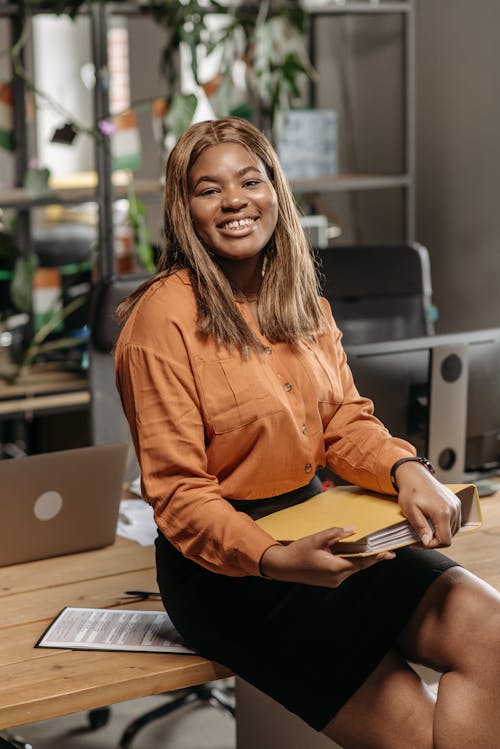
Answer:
[{"left": 115, "top": 118, "right": 500, "bottom": 749}]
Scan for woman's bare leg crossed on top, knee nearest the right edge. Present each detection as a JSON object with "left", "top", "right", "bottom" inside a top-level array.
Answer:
[{"left": 399, "top": 567, "right": 500, "bottom": 749}]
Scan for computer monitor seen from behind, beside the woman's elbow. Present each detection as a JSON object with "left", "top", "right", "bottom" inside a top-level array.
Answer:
[{"left": 345, "top": 328, "right": 500, "bottom": 483}]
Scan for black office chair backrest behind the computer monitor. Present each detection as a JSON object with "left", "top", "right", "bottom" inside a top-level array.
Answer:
[{"left": 315, "top": 242, "right": 435, "bottom": 345}]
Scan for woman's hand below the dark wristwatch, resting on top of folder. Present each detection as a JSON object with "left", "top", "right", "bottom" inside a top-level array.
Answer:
[{"left": 396, "top": 462, "right": 461, "bottom": 549}]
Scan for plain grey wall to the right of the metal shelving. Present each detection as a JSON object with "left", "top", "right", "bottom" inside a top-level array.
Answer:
[{"left": 416, "top": 0, "right": 500, "bottom": 331}]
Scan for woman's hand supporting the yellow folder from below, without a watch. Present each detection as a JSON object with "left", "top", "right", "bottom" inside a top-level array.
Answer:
[{"left": 260, "top": 528, "right": 394, "bottom": 588}]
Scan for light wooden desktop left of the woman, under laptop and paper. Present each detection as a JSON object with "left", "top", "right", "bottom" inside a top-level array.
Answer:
[{"left": 0, "top": 538, "right": 230, "bottom": 729}]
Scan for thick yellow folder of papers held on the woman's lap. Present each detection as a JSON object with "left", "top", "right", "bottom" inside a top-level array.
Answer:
[{"left": 257, "top": 484, "right": 482, "bottom": 556}]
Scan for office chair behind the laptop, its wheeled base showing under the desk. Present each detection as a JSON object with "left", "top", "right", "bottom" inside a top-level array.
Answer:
[{"left": 84, "top": 275, "right": 235, "bottom": 749}]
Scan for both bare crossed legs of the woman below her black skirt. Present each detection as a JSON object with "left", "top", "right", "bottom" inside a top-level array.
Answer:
[{"left": 324, "top": 567, "right": 500, "bottom": 749}]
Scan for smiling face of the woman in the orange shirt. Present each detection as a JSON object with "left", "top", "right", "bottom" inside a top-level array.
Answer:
[{"left": 189, "top": 143, "right": 278, "bottom": 260}]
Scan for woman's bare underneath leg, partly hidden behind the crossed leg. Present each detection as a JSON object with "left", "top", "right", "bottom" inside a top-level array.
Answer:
[{"left": 323, "top": 651, "right": 436, "bottom": 749}]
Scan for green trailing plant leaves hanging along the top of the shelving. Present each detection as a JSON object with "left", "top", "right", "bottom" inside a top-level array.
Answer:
[{"left": 14, "top": 0, "right": 315, "bottom": 149}]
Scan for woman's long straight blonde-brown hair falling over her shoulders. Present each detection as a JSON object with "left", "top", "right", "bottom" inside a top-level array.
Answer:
[{"left": 116, "top": 117, "right": 325, "bottom": 351}]
